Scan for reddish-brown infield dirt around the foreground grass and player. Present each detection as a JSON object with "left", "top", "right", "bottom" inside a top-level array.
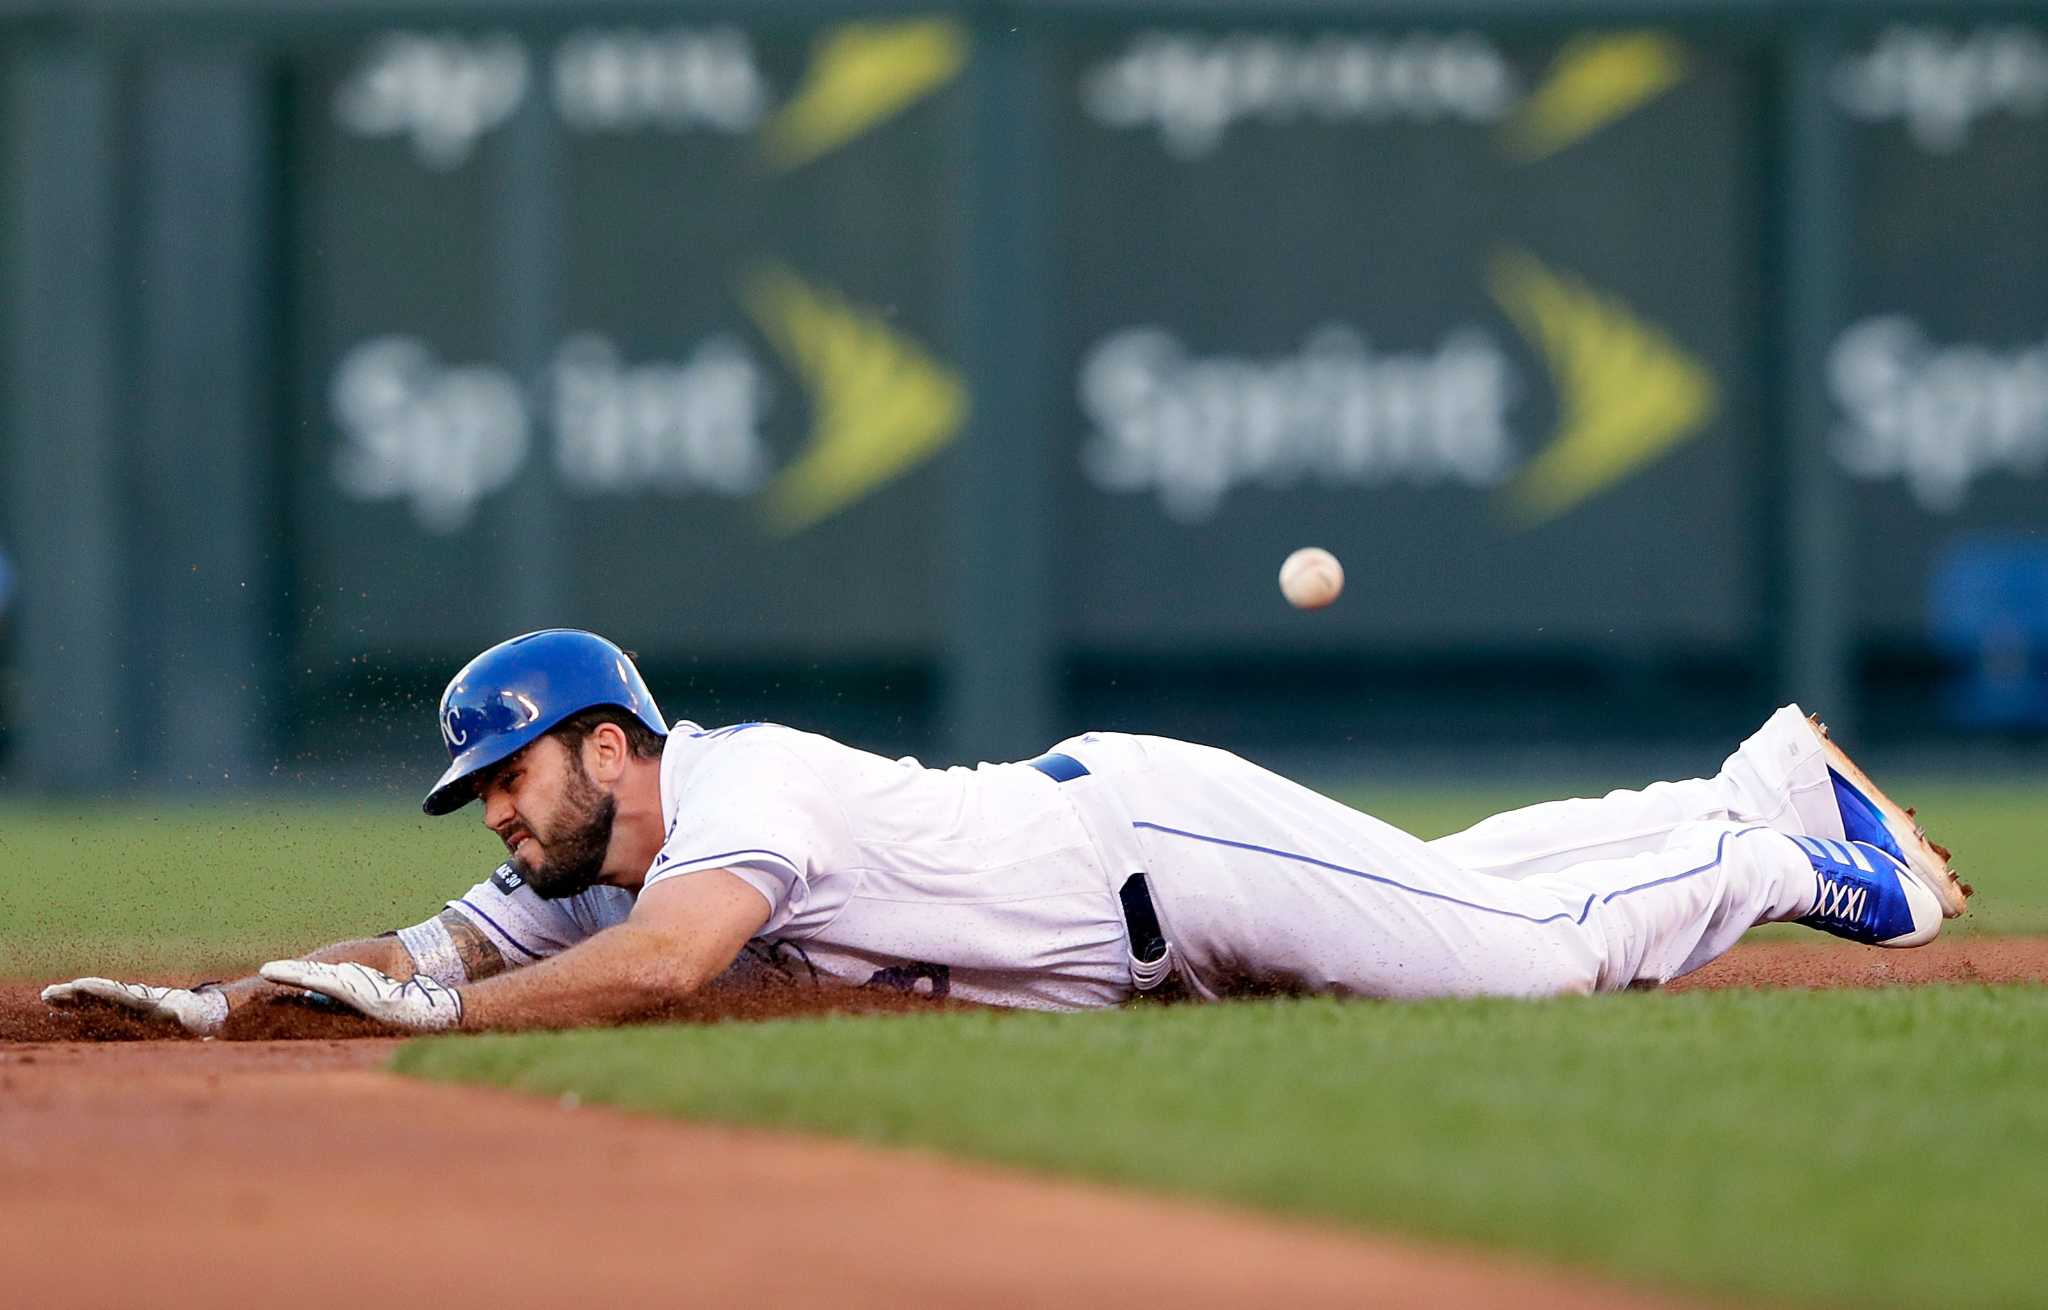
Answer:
[{"left": 0, "top": 937, "right": 2048, "bottom": 1310}]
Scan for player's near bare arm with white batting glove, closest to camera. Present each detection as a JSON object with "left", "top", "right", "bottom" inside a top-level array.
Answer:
[{"left": 262, "top": 870, "right": 768, "bottom": 1032}]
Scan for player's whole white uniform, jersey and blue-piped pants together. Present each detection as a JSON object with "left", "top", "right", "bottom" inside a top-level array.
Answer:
[{"left": 451, "top": 706, "right": 1841, "bottom": 1009}]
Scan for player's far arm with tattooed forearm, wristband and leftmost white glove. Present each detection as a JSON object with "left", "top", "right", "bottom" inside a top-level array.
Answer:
[{"left": 43, "top": 911, "right": 506, "bottom": 1036}]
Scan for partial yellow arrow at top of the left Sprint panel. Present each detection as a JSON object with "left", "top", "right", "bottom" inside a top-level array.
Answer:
[{"left": 762, "top": 18, "right": 969, "bottom": 170}]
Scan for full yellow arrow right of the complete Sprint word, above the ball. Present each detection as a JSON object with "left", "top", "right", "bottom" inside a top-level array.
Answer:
[{"left": 1489, "top": 252, "right": 1718, "bottom": 524}]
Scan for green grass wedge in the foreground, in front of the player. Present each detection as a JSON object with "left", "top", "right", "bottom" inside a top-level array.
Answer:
[{"left": 397, "top": 987, "right": 2048, "bottom": 1306}]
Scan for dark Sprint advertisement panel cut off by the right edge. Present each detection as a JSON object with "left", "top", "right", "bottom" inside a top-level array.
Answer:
[{"left": 1827, "top": 23, "right": 2048, "bottom": 638}]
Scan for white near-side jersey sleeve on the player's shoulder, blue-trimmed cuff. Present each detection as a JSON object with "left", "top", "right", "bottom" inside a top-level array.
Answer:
[{"left": 647, "top": 733, "right": 844, "bottom": 935}]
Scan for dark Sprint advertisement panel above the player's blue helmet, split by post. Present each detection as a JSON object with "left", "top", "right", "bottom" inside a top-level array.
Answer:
[{"left": 291, "top": 28, "right": 971, "bottom": 659}]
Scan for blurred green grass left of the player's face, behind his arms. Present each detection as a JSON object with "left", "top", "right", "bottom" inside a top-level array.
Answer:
[{"left": 0, "top": 798, "right": 502, "bottom": 978}]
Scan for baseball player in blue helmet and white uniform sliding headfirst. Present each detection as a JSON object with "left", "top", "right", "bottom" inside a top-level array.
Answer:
[{"left": 43, "top": 628, "right": 1968, "bottom": 1032}]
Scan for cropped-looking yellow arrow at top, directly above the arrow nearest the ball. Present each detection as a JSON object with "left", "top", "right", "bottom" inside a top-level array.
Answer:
[{"left": 1503, "top": 33, "right": 1686, "bottom": 160}]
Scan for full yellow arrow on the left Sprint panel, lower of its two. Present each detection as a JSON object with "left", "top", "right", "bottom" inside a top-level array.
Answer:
[{"left": 743, "top": 266, "right": 969, "bottom": 534}]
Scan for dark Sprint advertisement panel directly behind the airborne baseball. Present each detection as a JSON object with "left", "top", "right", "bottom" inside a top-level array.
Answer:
[{"left": 1059, "top": 29, "right": 1765, "bottom": 651}]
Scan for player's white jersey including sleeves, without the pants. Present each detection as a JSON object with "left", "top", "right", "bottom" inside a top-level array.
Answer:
[{"left": 451, "top": 723, "right": 1130, "bottom": 1009}]
